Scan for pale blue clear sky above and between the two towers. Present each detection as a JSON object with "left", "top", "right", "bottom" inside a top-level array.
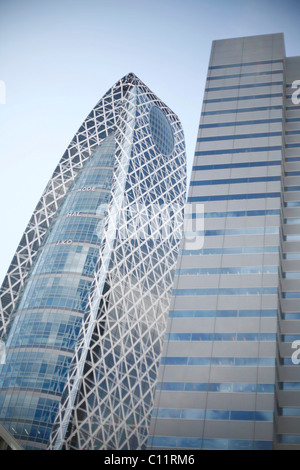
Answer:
[{"left": 0, "top": 0, "right": 300, "bottom": 284}]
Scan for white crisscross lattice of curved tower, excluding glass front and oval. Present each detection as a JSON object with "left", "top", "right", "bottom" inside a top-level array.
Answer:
[{"left": 0, "top": 74, "right": 186, "bottom": 449}]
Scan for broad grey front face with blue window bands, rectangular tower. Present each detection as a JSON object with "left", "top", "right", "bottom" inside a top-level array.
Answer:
[{"left": 148, "top": 35, "right": 284, "bottom": 449}]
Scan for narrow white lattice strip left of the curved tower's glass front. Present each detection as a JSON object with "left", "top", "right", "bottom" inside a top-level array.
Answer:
[{"left": 0, "top": 76, "right": 130, "bottom": 338}]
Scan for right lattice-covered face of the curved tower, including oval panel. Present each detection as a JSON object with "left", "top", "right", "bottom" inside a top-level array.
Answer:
[{"left": 50, "top": 79, "right": 185, "bottom": 450}]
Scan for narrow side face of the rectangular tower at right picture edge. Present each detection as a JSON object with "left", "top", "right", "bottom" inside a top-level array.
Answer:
[{"left": 274, "top": 53, "right": 300, "bottom": 450}]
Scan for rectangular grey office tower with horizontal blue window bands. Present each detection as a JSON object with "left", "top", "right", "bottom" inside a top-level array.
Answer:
[{"left": 148, "top": 34, "right": 300, "bottom": 449}]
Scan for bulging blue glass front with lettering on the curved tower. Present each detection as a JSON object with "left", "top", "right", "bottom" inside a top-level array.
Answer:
[{"left": 0, "top": 134, "right": 115, "bottom": 448}]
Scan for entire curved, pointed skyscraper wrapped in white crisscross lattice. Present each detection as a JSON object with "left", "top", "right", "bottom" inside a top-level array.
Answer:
[{"left": 0, "top": 74, "right": 186, "bottom": 449}]
